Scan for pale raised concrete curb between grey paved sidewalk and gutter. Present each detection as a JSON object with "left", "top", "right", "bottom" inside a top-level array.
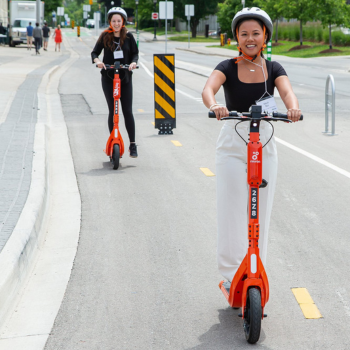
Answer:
[{"left": 0, "top": 67, "right": 57, "bottom": 325}]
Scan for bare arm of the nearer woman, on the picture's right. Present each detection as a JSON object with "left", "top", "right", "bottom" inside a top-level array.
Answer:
[{"left": 275, "top": 75, "right": 301, "bottom": 122}]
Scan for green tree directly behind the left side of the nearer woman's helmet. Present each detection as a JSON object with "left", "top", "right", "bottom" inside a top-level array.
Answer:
[{"left": 217, "top": 0, "right": 257, "bottom": 38}]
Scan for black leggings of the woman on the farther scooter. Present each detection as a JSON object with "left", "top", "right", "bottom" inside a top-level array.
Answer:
[{"left": 101, "top": 74, "right": 135, "bottom": 142}]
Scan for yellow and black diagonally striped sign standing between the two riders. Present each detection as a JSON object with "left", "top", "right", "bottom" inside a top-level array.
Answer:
[{"left": 153, "top": 54, "right": 176, "bottom": 134}]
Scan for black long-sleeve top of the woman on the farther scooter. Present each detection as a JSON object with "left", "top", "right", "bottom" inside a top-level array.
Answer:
[{"left": 91, "top": 32, "right": 139, "bottom": 64}]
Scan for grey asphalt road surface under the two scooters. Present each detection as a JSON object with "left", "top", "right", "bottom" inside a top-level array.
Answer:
[{"left": 45, "top": 30, "right": 350, "bottom": 350}]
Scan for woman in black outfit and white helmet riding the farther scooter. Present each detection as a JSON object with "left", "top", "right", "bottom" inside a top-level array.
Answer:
[{"left": 91, "top": 7, "right": 139, "bottom": 158}]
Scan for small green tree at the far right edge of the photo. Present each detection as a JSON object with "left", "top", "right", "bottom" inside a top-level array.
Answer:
[{"left": 316, "top": 0, "right": 350, "bottom": 50}]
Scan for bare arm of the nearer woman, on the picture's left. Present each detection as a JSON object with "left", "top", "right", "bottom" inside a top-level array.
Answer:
[{"left": 202, "top": 70, "right": 229, "bottom": 120}]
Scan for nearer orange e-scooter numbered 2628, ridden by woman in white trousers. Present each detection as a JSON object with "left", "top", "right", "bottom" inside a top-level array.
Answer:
[{"left": 209, "top": 106, "right": 303, "bottom": 344}]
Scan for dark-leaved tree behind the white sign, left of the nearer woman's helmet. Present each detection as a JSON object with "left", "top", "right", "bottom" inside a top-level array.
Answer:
[{"left": 174, "top": 0, "right": 218, "bottom": 38}]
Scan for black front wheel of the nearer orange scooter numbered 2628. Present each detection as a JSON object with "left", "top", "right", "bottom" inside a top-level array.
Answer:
[{"left": 243, "top": 288, "right": 262, "bottom": 344}]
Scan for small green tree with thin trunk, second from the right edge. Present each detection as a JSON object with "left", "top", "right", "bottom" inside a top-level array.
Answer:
[{"left": 277, "top": 0, "right": 314, "bottom": 46}]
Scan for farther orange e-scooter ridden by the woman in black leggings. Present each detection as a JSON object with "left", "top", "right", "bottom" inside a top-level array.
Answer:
[{"left": 96, "top": 61, "right": 139, "bottom": 170}]
